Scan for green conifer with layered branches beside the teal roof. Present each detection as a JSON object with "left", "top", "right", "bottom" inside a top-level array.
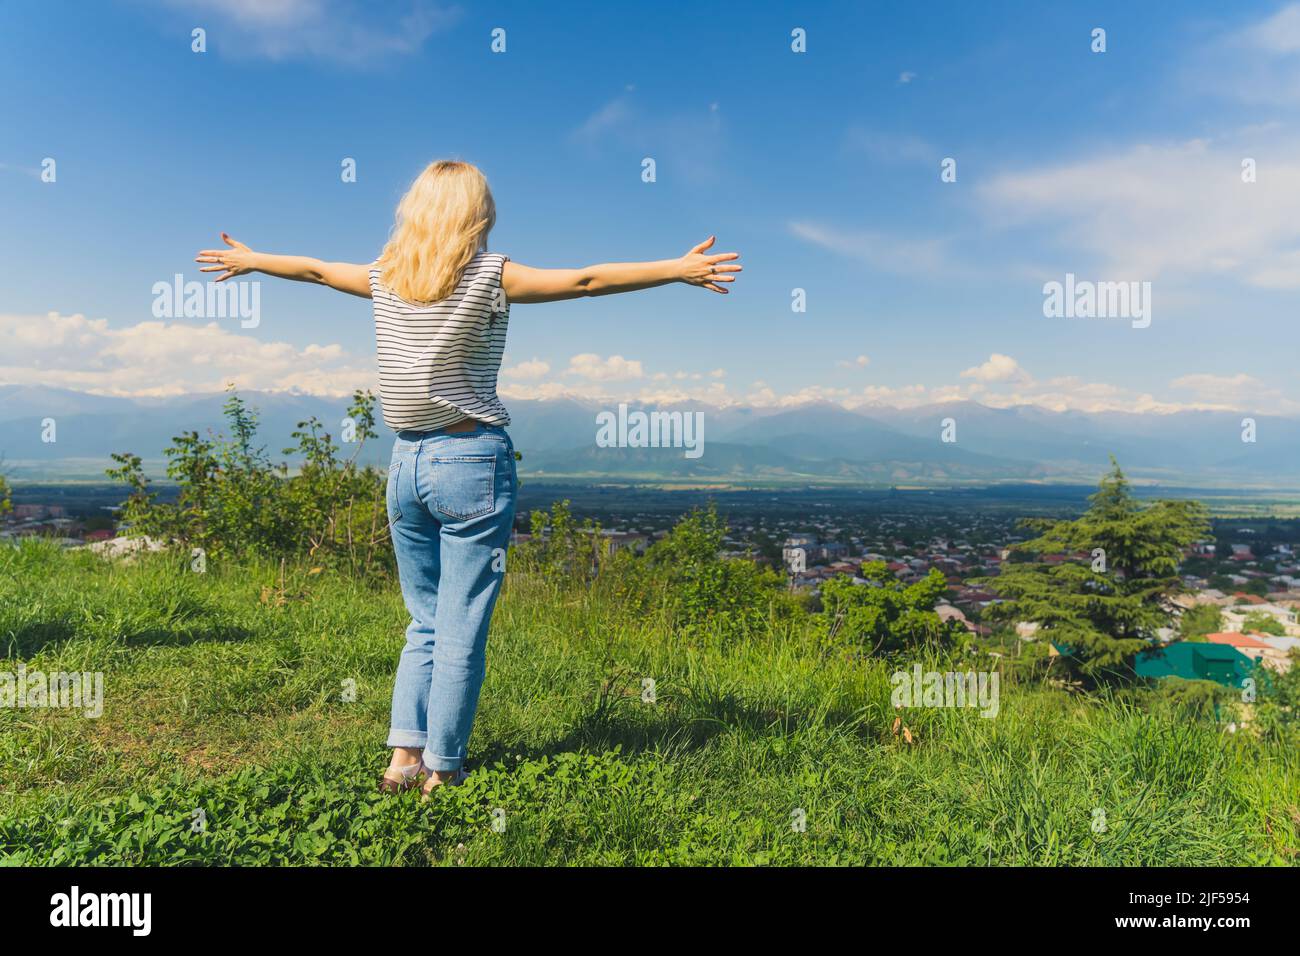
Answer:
[{"left": 979, "top": 458, "right": 1209, "bottom": 678}]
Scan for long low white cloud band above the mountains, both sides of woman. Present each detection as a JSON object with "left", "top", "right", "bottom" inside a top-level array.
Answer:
[{"left": 0, "top": 312, "right": 1300, "bottom": 415}]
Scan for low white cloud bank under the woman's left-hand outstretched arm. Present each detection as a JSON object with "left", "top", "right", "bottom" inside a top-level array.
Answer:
[{"left": 0, "top": 312, "right": 378, "bottom": 397}]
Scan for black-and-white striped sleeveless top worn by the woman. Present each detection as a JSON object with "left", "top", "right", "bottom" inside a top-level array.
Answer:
[{"left": 371, "top": 252, "right": 510, "bottom": 432}]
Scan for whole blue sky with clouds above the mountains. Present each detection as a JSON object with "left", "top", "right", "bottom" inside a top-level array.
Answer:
[{"left": 0, "top": 0, "right": 1300, "bottom": 414}]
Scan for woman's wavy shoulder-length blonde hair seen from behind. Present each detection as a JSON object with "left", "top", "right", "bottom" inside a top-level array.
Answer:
[{"left": 376, "top": 160, "right": 497, "bottom": 302}]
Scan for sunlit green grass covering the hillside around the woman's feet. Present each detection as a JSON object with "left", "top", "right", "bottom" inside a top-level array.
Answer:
[{"left": 0, "top": 546, "right": 1300, "bottom": 865}]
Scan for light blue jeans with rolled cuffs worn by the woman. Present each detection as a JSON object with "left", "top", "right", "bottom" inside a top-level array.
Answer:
[{"left": 387, "top": 425, "right": 517, "bottom": 771}]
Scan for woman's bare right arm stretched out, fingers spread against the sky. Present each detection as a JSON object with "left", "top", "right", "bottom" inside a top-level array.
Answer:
[{"left": 501, "top": 235, "right": 741, "bottom": 302}]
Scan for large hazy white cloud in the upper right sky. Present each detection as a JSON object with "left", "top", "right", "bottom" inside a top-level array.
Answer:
[{"left": 979, "top": 3, "right": 1300, "bottom": 287}]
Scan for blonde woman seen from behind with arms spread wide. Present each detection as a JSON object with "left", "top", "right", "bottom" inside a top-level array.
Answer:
[{"left": 195, "top": 160, "right": 741, "bottom": 796}]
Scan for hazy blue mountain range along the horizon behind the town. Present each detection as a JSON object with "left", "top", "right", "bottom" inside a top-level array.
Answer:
[{"left": 0, "top": 385, "right": 1300, "bottom": 489}]
